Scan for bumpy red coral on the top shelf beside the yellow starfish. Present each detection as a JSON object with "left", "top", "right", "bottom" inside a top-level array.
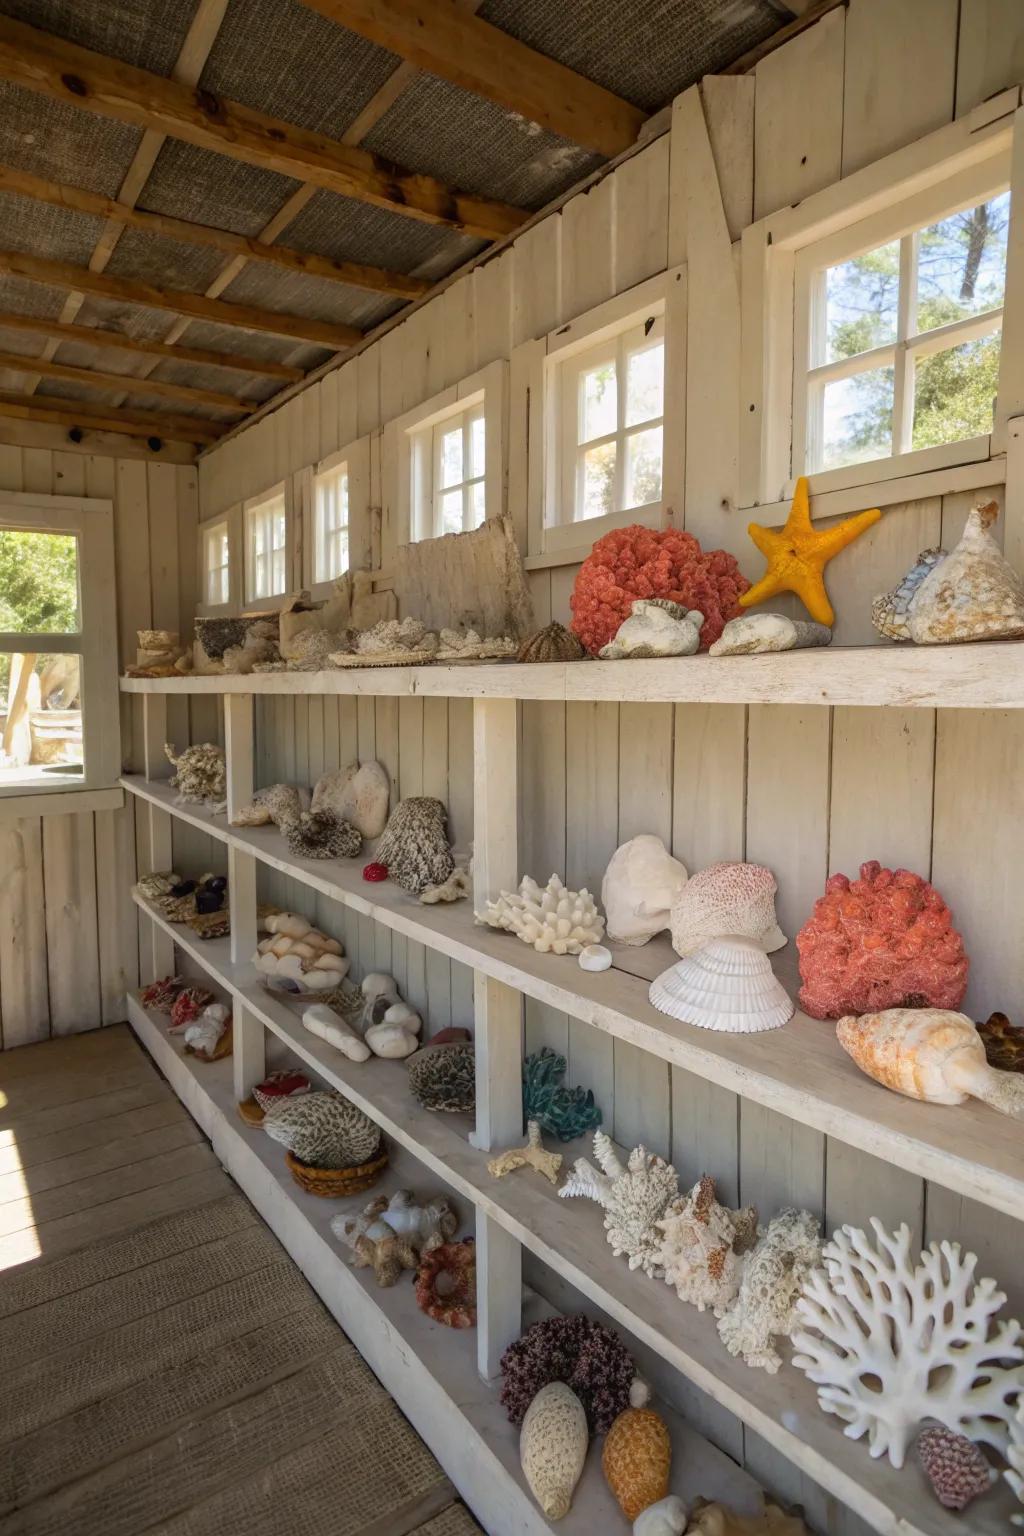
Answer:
[{"left": 570, "top": 524, "right": 751, "bottom": 654}]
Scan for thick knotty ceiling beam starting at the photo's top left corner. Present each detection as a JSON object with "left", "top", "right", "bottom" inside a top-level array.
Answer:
[{"left": 0, "top": 17, "right": 525, "bottom": 240}]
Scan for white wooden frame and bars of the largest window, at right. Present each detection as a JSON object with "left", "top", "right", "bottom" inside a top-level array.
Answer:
[{"left": 740, "top": 88, "right": 1024, "bottom": 521}]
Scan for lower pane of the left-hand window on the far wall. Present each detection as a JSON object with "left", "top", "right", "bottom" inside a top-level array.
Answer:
[{"left": 0, "top": 651, "right": 84, "bottom": 790}]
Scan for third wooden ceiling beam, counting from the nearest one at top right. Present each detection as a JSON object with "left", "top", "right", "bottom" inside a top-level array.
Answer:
[{"left": 0, "top": 166, "right": 430, "bottom": 300}]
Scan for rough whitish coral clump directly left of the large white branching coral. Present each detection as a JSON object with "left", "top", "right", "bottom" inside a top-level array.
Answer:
[{"left": 718, "top": 1209, "right": 821, "bottom": 1376}]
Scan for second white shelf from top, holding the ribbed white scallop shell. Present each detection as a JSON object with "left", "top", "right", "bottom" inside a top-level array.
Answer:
[{"left": 121, "top": 776, "right": 1024, "bottom": 1217}]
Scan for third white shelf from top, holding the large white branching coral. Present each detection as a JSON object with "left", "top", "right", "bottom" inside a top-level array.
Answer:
[{"left": 130, "top": 927, "right": 1010, "bottom": 1536}]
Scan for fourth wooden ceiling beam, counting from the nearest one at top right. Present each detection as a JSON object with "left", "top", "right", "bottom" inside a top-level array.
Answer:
[{"left": 0, "top": 250, "right": 362, "bottom": 349}]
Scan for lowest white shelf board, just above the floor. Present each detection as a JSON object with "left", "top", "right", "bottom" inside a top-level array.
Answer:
[{"left": 127, "top": 995, "right": 760, "bottom": 1536}]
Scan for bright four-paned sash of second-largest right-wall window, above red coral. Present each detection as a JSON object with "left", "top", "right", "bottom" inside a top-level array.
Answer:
[{"left": 554, "top": 315, "right": 665, "bottom": 524}]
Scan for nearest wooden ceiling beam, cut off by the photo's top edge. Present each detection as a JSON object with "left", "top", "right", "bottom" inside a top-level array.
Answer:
[{"left": 302, "top": 0, "right": 646, "bottom": 158}]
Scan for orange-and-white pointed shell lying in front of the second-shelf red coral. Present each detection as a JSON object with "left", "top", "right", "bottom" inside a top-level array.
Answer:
[{"left": 835, "top": 1008, "right": 1024, "bottom": 1120}]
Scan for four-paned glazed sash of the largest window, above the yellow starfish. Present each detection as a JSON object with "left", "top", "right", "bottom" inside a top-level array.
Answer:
[{"left": 792, "top": 190, "right": 1010, "bottom": 475}]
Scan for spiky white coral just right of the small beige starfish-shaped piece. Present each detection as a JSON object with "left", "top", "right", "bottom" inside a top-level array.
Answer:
[{"left": 559, "top": 1130, "right": 679, "bottom": 1279}]
